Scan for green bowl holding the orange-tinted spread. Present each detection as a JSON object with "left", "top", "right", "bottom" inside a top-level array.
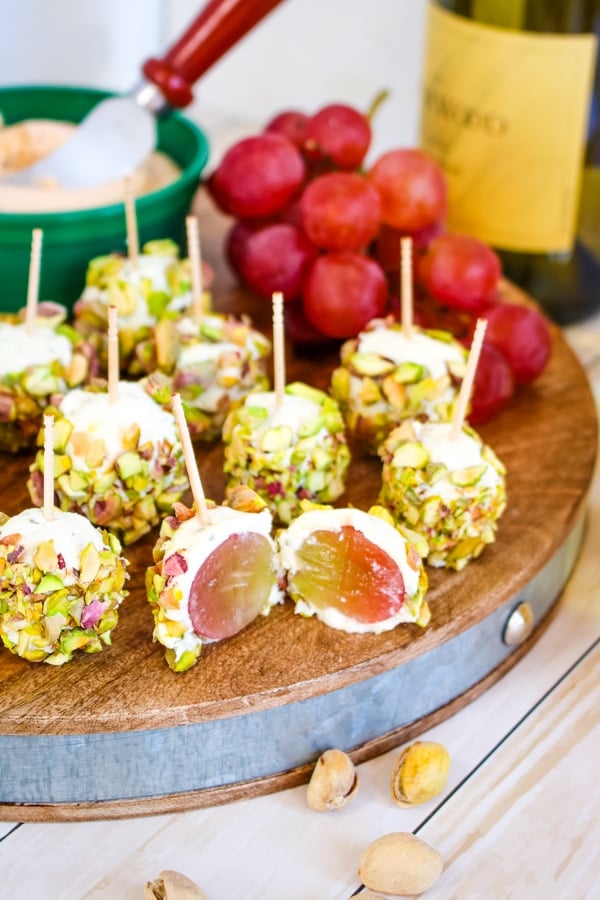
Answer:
[{"left": 0, "top": 86, "right": 209, "bottom": 312}]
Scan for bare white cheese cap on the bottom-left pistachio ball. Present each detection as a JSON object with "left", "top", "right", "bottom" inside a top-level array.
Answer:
[{"left": 0, "top": 507, "right": 105, "bottom": 584}]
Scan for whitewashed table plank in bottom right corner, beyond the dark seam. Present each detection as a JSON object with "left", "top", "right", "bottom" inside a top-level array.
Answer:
[{"left": 418, "top": 643, "right": 600, "bottom": 900}]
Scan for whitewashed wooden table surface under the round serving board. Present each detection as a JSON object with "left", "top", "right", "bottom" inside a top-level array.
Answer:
[{"left": 0, "top": 316, "right": 600, "bottom": 900}]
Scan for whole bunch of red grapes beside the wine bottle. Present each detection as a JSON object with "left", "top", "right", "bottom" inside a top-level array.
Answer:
[{"left": 206, "top": 103, "right": 551, "bottom": 424}]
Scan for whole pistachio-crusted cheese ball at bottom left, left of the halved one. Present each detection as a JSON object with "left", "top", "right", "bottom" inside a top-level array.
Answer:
[{"left": 0, "top": 508, "right": 128, "bottom": 666}]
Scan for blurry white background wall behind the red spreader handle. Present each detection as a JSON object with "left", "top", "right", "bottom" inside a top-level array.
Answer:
[{"left": 0, "top": 0, "right": 426, "bottom": 160}]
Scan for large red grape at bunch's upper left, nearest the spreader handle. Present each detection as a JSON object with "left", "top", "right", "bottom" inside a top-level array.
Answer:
[{"left": 207, "top": 134, "right": 306, "bottom": 219}]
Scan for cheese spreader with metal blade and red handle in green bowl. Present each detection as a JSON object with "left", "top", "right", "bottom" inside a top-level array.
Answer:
[{"left": 0, "top": 0, "right": 281, "bottom": 188}]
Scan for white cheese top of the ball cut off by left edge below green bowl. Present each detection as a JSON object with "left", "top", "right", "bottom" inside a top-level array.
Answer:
[{"left": 0, "top": 322, "right": 73, "bottom": 376}]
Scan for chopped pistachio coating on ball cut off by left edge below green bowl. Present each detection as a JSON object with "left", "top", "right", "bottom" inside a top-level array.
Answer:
[{"left": 0, "top": 302, "right": 97, "bottom": 453}]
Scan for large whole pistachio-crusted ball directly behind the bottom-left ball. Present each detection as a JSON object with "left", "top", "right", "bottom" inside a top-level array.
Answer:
[{"left": 28, "top": 381, "right": 189, "bottom": 544}]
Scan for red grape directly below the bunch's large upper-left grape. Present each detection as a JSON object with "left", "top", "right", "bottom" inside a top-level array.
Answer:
[{"left": 238, "top": 222, "right": 318, "bottom": 299}]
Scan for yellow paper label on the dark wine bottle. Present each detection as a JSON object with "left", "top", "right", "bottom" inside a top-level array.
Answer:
[{"left": 421, "top": 4, "right": 596, "bottom": 252}]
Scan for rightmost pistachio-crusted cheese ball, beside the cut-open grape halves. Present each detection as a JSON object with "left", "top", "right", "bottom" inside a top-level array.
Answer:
[{"left": 379, "top": 421, "right": 506, "bottom": 570}]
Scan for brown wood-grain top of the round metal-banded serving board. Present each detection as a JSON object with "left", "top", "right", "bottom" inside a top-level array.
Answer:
[{"left": 0, "top": 199, "right": 597, "bottom": 735}]
